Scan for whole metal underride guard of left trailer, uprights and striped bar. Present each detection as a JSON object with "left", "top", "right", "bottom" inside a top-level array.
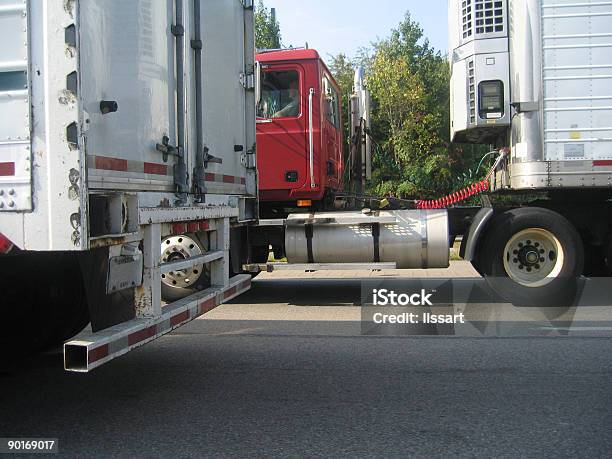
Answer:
[{"left": 64, "top": 208, "right": 241, "bottom": 372}]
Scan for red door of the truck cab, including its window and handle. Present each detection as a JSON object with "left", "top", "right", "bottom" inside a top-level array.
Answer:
[{"left": 257, "top": 63, "right": 309, "bottom": 196}]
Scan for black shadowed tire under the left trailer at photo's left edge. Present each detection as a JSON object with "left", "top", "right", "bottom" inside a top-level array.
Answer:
[{"left": 0, "top": 252, "right": 89, "bottom": 357}]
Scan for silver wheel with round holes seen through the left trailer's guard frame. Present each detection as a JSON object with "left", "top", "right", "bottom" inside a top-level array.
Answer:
[{"left": 161, "top": 234, "right": 210, "bottom": 301}]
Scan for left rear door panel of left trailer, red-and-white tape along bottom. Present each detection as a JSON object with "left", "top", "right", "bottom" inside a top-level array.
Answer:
[{"left": 79, "top": 0, "right": 176, "bottom": 191}]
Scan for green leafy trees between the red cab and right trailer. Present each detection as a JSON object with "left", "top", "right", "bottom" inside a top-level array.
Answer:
[{"left": 364, "top": 13, "right": 480, "bottom": 197}]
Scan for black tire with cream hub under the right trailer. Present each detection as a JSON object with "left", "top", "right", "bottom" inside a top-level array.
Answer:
[{"left": 477, "top": 207, "right": 584, "bottom": 307}]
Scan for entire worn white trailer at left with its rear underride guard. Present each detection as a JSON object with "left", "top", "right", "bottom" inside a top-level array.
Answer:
[{"left": 0, "top": 0, "right": 257, "bottom": 371}]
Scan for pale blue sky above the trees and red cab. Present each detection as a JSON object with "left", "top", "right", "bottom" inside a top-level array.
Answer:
[{"left": 264, "top": 0, "right": 448, "bottom": 60}]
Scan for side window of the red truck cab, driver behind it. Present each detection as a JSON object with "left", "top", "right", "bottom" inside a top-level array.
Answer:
[{"left": 257, "top": 70, "right": 301, "bottom": 118}]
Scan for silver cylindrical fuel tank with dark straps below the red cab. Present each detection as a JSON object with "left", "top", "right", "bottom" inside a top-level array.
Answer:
[{"left": 285, "top": 210, "right": 449, "bottom": 269}]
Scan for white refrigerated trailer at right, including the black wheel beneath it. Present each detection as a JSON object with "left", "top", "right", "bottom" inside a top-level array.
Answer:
[{"left": 449, "top": 0, "right": 612, "bottom": 305}]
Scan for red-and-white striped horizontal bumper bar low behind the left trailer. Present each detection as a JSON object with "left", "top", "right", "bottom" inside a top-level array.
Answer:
[{"left": 64, "top": 274, "right": 251, "bottom": 373}]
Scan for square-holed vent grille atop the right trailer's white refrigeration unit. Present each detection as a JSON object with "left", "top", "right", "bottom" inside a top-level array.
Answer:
[{"left": 461, "top": 0, "right": 506, "bottom": 40}]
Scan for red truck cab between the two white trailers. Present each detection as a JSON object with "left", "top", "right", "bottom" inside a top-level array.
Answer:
[{"left": 256, "top": 49, "right": 344, "bottom": 212}]
